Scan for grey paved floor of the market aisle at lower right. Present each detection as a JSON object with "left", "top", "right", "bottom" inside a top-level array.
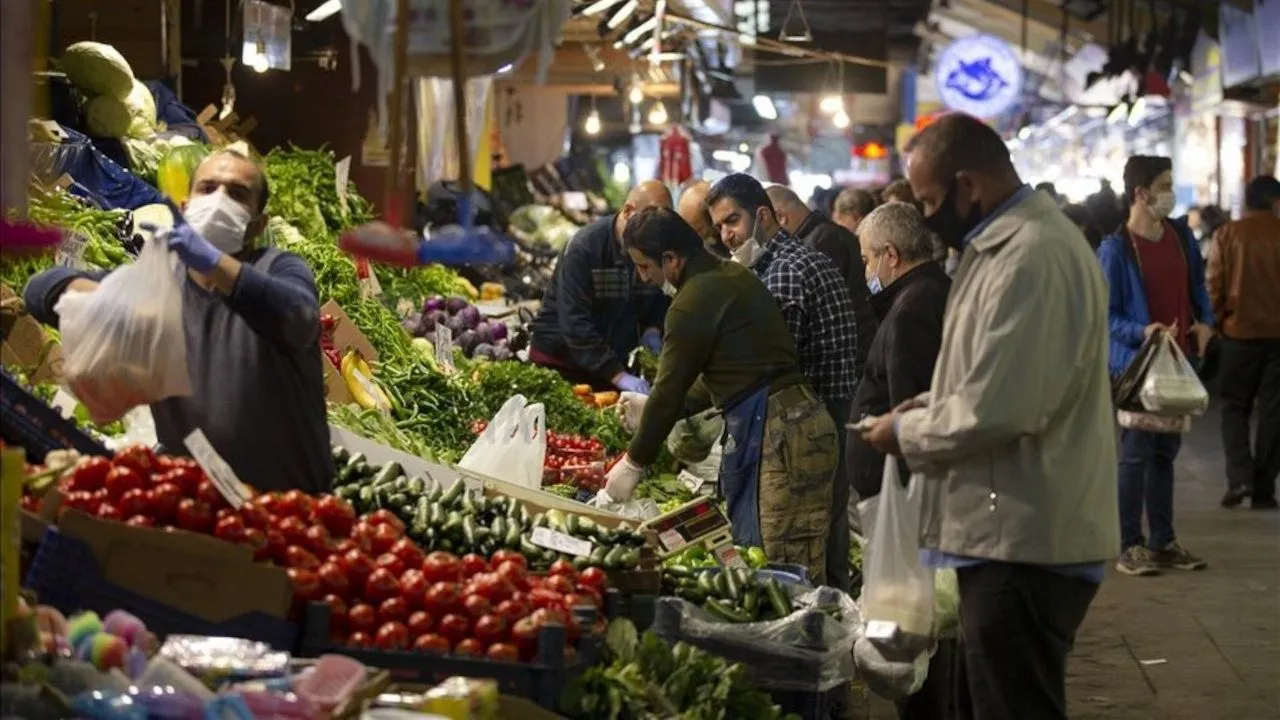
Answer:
[{"left": 1068, "top": 399, "right": 1280, "bottom": 720}]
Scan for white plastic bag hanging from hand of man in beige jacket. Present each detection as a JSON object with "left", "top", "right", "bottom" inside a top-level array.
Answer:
[{"left": 860, "top": 459, "right": 933, "bottom": 637}]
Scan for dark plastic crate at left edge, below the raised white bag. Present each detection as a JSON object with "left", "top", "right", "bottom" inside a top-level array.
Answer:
[{"left": 0, "top": 372, "right": 110, "bottom": 462}]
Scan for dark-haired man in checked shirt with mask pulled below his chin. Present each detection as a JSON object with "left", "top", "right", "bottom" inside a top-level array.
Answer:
[{"left": 707, "top": 173, "right": 858, "bottom": 591}]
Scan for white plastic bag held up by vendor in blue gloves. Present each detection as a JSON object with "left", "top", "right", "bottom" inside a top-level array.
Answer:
[{"left": 54, "top": 240, "right": 191, "bottom": 423}]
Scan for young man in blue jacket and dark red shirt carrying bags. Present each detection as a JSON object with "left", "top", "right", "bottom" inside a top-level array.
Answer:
[{"left": 1098, "top": 155, "right": 1213, "bottom": 575}]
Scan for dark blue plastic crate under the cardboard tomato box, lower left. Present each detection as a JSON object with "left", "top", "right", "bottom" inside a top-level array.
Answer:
[{"left": 26, "top": 528, "right": 298, "bottom": 651}]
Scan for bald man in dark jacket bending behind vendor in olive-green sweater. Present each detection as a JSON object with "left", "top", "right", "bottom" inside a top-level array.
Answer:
[{"left": 529, "top": 181, "right": 672, "bottom": 393}]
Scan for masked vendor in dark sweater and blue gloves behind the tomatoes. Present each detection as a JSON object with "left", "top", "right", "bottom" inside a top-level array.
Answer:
[{"left": 24, "top": 151, "right": 333, "bottom": 493}]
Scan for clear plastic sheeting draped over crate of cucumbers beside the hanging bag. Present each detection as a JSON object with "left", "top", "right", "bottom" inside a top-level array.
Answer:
[{"left": 653, "top": 584, "right": 863, "bottom": 692}]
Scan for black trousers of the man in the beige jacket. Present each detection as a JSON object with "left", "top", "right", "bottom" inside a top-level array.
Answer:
[{"left": 956, "top": 562, "right": 1098, "bottom": 720}]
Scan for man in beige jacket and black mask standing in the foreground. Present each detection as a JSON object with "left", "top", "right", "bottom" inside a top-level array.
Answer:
[{"left": 865, "top": 114, "right": 1120, "bottom": 720}]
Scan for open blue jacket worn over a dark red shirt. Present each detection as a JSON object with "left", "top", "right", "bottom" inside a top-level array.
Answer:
[{"left": 1098, "top": 219, "right": 1213, "bottom": 375}]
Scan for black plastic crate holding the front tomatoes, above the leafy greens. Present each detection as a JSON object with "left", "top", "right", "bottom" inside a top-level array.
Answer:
[{"left": 298, "top": 602, "right": 604, "bottom": 710}]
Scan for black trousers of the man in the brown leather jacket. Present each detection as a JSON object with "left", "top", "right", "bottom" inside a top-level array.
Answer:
[{"left": 1220, "top": 337, "right": 1280, "bottom": 500}]
